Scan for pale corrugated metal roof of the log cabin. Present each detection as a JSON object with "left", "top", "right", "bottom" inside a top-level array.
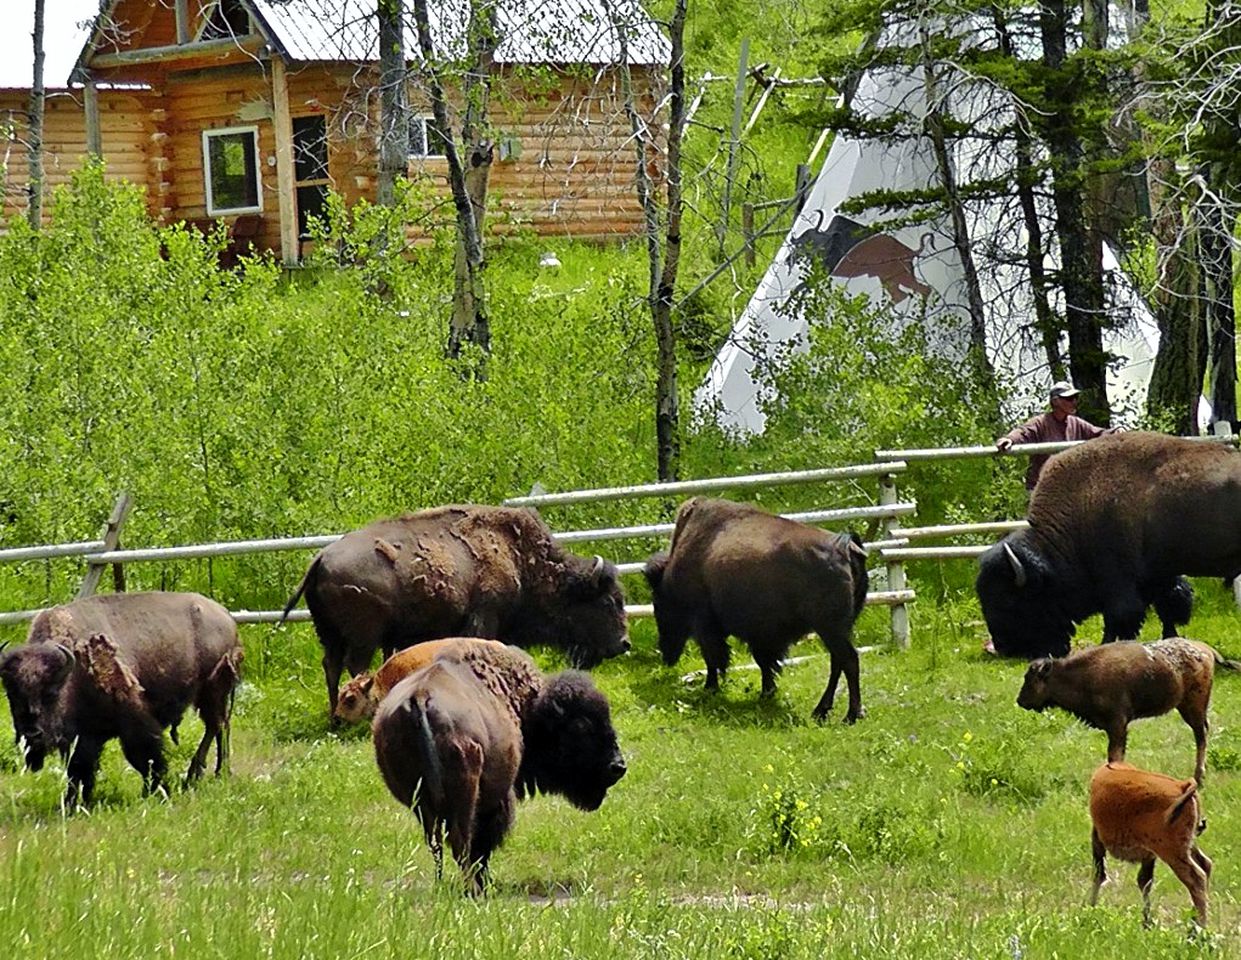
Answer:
[{"left": 249, "top": 0, "right": 670, "bottom": 66}]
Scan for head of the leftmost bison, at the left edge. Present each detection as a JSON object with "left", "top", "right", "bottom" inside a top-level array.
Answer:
[{"left": 0, "top": 644, "right": 76, "bottom": 770}]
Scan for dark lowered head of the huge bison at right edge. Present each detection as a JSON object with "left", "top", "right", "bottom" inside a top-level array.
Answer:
[{"left": 974, "top": 531, "right": 1073, "bottom": 659}]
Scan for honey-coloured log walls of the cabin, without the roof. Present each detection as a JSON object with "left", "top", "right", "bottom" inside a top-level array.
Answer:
[{"left": 0, "top": 55, "right": 658, "bottom": 251}]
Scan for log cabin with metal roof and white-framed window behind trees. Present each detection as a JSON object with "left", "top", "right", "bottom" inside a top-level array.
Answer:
[{"left": 0, "top": 0, "right": 669, "bottom": 264}]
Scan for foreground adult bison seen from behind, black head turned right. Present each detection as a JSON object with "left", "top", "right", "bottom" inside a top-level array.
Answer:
[{"left": 372, "top": 645, "right": 625, "bottom": 894}]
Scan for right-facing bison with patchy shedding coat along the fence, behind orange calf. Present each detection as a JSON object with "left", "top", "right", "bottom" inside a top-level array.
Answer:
[{"left": 282, "top": 506, "right": 629, "bottom": 713}]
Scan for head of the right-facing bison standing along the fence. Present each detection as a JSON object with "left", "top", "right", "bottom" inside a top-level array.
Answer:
[{"left": 551, "top": 557, "right": 629, "bottom": 670}]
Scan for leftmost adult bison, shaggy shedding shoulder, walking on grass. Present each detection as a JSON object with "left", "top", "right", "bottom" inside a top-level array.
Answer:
[{"left": 0, "top": 593, "right": 242, "bottom": 806}]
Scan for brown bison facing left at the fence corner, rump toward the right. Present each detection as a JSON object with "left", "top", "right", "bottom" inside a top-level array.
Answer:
[{"left": 644, "top": 497, "right": 869, "bottom": 723}]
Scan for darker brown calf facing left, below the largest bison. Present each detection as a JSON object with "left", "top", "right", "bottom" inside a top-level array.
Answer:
[{"left": 1016, "top": 638, "right": 1219, "bottom": 783}]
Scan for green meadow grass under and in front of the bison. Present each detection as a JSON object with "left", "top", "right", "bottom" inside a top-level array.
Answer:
[{"left": 0, "top": 582, "right": 1241, "bottom": 960}]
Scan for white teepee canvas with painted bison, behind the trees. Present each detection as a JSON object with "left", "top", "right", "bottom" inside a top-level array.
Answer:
[{"left": 695, "top": 23, "right": 1158, "bottom": 433}]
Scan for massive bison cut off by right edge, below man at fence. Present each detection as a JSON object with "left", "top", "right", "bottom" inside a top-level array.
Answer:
[{"left": 975, "top": 433, "right": 1241, "bottom": 659}]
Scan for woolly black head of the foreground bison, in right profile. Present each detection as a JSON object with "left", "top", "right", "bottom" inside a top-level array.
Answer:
[{"left": 519, "top": 670, "right": 625, "bottom": 810}]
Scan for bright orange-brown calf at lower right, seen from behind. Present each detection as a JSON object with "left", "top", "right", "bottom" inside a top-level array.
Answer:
[{"left": 1090, "top": 763, "right": 1211, "bottom": 927}]
